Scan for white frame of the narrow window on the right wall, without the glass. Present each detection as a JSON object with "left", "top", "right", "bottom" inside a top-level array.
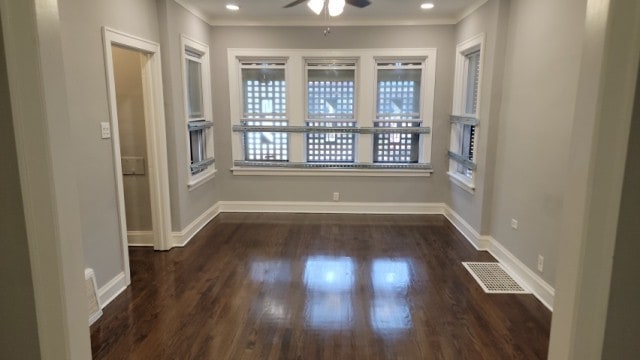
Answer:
[{"left": 447, "top": 33, "right": 485, "bottom": 194}]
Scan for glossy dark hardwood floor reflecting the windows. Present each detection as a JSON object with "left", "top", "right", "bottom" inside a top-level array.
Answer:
[{"left": 91, "top": 214, "right": 551, "bottom": 360}]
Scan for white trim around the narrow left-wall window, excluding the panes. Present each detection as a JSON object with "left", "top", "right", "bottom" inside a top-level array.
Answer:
[{"left": 180, "top": 35, "right": 217, "bottom": 191}]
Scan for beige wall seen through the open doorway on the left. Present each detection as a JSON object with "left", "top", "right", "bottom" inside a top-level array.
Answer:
[{"left": 113, "top": 46, "right": 152, "bottom": 231}]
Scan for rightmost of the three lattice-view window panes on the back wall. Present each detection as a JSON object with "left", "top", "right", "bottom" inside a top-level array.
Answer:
[{"left": 373, "top": 62, "right": 424, "bottom": 163}]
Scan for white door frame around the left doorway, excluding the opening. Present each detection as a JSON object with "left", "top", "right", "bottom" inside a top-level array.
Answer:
[{"left": 102, "top": 27, "right": 172, "bottom": 285}]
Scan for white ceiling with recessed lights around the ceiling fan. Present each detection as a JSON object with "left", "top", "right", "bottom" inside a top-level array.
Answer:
[{"left": 176, "top": 0, "right": 487, "bottom": 26}]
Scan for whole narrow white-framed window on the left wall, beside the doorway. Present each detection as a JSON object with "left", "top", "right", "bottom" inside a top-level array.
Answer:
[{"left": 182, "top": 36, "right": 215, "bottom": 188}]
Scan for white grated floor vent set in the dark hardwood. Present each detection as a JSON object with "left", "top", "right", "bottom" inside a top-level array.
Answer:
[{"left": 462, "top": 262, "right": 530, "bottom": 294}]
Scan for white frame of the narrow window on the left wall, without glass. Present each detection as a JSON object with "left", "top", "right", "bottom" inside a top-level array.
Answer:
[{"left": 180, "top": 35, "right": 217, "bottom": 191}]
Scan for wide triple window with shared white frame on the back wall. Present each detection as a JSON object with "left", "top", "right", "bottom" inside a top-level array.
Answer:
[{"left": 228, "top": 49, "right": 435, "bottom": 176}]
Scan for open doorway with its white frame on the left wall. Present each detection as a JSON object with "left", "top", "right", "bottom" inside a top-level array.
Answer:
[{"left": 103, "top": 27, "right": 173, "bottom": 285}]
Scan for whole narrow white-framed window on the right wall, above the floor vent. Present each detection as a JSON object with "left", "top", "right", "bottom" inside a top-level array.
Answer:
[{"left": 449, "top": 35, "right": 484, "bottom": 191}]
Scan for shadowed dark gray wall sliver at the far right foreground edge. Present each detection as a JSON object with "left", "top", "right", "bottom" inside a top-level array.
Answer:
[{"left": 602, "top": 61, "right": 640, "bottom": 359}]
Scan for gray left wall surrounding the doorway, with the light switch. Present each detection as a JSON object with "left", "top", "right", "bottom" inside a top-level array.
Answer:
[{"left": 59, "top": 0, "right": 219, "bottom": 287}]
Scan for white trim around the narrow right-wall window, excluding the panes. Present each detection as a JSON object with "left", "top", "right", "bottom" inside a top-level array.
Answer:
[{"left": 447, "top": 33, "right": 485, "bottom": 194}]
